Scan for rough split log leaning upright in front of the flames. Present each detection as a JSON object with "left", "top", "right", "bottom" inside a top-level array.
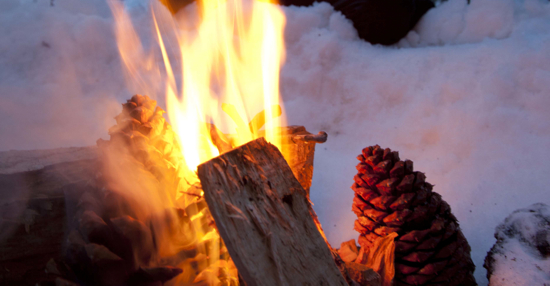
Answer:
[{"left": 198, "top": 138, "right": 347, "bottom": 285}]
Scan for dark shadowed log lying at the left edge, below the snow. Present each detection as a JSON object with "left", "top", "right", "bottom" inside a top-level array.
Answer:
[{"left": 0, "top": 160, "right": 98, "bottom": 285}]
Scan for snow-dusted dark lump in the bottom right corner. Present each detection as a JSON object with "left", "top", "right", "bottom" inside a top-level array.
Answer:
[{"left": 484, "top": 203, "right": 550, "bottom": 286}]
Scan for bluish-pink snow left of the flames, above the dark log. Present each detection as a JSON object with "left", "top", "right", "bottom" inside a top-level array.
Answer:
[{"left": 0, "top": 0, "right": 128, "bottom": 150}]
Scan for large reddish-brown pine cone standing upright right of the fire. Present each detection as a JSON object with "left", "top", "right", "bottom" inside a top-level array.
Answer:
[{"left": 352, "top": 145, "right": 477, "bottom": 285}]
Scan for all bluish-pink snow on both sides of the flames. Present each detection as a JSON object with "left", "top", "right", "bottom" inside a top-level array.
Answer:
[{"left": 0, "top": 0, "right": 550, "bottom": 285}]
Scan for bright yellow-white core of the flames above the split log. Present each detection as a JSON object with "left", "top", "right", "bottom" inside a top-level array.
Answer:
[{"left": 160, "top": 0, "right": 284, "bottom": 170}]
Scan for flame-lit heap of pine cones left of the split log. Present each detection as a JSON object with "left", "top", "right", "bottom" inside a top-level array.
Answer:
[{"left": 62, "top": 95, "right": 236, "bottom": 286}]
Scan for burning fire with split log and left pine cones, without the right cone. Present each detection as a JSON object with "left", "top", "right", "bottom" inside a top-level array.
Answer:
[{"left": 67, "top": 0, "right": 350, "bottom": 285}]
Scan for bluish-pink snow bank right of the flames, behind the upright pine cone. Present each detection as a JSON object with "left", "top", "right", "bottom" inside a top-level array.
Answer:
[{"left": 281, "top": 0, "right": 550, "bottom": 285}]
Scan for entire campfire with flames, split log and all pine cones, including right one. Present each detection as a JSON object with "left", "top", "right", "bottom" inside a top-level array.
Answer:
[{"left": 0, "top": 0, "right": 475, "bottom": 286}]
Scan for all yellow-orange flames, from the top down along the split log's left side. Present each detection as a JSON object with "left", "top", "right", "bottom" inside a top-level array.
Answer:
[{"left": 109, "top": 0, "right": 285, "bottom": 285}]
